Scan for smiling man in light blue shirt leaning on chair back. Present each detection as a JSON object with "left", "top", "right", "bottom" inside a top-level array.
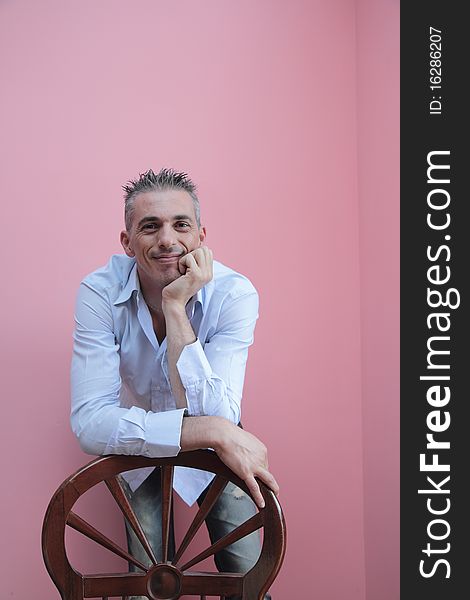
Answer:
[{"left": 71, "top": 169, "right": 278, "bottom": 596}]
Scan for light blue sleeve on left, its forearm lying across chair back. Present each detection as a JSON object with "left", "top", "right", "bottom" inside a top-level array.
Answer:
[{"left": 71, "top": 283, "right": 184, "bottom": 457}]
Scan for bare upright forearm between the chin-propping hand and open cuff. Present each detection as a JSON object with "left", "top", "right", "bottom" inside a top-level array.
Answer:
[{"left": 163, "top": 302, "right": 196, "bottom": 408}]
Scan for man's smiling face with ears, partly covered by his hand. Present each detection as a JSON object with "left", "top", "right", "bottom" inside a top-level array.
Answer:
[{"left": 121, "top": 189, "right": 205, "bottom": 289}]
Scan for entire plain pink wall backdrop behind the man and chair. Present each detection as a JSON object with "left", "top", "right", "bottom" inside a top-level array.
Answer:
[{"left": 0, "top": 0, "right": 399, "bottom": 600}]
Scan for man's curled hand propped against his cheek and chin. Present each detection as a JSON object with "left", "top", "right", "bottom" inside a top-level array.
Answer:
[{"left": 162, "top": 246, "right": 213, "bottom": 312}]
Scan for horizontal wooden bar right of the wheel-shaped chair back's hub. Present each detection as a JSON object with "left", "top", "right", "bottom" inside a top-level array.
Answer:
[{"left": 181, "top": 571, "right": 243, "bottom": 598}]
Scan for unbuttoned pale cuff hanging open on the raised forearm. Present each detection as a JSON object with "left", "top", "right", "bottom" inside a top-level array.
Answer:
[{"left": 176, "top": 339, "right": 212, "bottom": 416}]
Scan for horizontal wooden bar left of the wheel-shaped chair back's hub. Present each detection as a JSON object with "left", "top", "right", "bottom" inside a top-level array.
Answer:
[{"left": 83, "top": 573, "right": 147, "bottom": 598}]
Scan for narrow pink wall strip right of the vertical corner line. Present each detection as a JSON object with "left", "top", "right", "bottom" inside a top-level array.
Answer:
[{"left": 357, "top": 0, "right": 400, "bottom": 600}]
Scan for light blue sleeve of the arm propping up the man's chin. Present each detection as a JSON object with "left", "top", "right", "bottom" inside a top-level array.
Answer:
[{"left": 176, "top": 291, "right": 258, "bottom": 423}]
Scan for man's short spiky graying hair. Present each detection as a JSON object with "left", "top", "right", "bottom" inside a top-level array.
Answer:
[{"left": 122, "top": 169, "right": 201, "bottom": 231}]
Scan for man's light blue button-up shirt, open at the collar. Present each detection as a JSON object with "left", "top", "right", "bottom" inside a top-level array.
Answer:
[{"left": 71, "top": 255, "right": 258, "bottom": 504}]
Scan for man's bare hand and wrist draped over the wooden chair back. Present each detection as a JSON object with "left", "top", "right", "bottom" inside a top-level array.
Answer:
[{"left": 181, "top": 416, "right": 279, "bottom": 508}]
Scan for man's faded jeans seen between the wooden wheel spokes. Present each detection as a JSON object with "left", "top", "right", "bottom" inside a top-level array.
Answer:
[{"left": 126, "top": 468, "right": 271, "bottom": 600}]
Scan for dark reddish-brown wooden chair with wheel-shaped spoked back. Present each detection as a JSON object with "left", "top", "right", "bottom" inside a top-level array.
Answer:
[{"left": 42, "top": 450, "right": 286, "bottom": 600}]
